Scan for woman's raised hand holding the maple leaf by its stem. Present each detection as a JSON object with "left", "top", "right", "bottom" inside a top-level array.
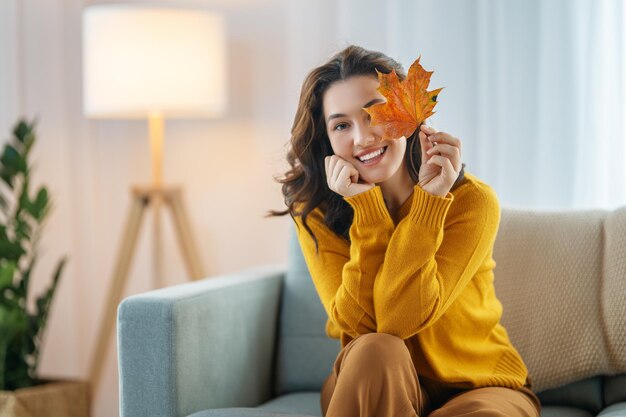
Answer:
[{"left": 419, "top": 124, "right": 462, "bottom": 197}]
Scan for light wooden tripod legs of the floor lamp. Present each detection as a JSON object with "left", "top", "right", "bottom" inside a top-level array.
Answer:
[{"left": 89, "top": 185, "right": 203, "bottom": 392}]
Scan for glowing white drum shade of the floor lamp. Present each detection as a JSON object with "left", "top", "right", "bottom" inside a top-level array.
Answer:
[{"left": 83, "top": 4, "right": 227, "bottom": 119}]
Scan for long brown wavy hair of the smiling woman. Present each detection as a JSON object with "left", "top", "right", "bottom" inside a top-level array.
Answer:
[{"left": 268, "top": 45, "right": 463, "bottom": 247}]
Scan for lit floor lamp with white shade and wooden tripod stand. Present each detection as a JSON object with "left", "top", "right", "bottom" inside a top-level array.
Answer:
[{"left": 83, "top": 4, "right": 226, "bottom": 392}]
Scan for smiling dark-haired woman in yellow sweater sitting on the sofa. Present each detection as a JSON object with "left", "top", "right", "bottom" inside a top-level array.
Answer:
[{"left": 273, "top": 46, "right": 540, "bottom": 417}]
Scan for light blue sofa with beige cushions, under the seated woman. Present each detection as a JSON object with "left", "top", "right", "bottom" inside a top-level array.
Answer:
[{"left": 117, "top": 208, "right": 626, "bottom": 417}]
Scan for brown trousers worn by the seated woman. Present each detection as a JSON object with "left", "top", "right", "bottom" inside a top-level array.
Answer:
[{"left": 321, "top": 333, "right": 541, "bottom": 417}]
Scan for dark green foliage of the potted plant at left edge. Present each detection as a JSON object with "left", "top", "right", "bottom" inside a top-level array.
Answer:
[{"left": 0, "top": 120, "right": 65, "bottom": 390}]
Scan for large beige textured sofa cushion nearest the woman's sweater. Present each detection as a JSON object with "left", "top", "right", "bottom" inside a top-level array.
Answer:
[{"left": 494, "top": 209, "right": 626, "bottom": 391}]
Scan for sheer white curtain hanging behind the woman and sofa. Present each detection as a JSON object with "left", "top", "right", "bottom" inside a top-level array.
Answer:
[{"left": 289, "top": 0, "right": 626, "bottom": 209}]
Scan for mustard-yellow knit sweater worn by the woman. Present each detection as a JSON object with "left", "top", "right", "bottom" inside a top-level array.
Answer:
[{"left": 295, "top": 173, "right": 528, "bottom": 388}]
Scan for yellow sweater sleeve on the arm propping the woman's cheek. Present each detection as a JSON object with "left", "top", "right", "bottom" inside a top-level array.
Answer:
[{"left": 295, "top": 187, "right": 394, "bottom": 338}]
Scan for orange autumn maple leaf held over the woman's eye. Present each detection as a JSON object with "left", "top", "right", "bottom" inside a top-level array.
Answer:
[{"left": 363, "top": 57, "right": 443, "bottom": 139}]
